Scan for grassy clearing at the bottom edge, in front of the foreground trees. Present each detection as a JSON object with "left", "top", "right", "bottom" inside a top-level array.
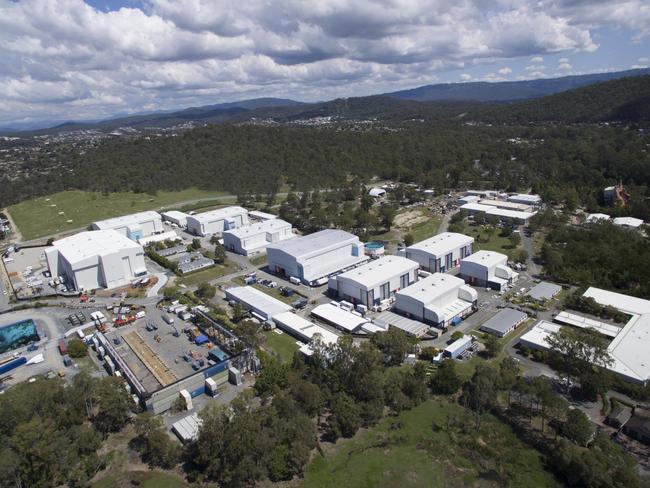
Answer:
[{"left": 301, "top": 400, "right": 560, "bottom": 488}]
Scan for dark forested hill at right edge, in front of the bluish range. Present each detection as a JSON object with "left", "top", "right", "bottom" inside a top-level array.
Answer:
[{"left": 478, "top": 75, "right": 650, "bottom": 124}]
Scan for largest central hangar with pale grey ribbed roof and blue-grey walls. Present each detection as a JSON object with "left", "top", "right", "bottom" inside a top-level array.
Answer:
[{"left": 266, "top": 229, "right": 369, "bottom": 285}]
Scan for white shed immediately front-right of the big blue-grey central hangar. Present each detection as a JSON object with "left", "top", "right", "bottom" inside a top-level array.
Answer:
[{"left": 329, "top": 256, "right": 419, "bottom": 307}]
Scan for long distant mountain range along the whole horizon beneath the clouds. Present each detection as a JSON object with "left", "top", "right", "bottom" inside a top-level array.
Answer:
[{"left": 0, "top": 69, "right": 650, "bottom": 135}]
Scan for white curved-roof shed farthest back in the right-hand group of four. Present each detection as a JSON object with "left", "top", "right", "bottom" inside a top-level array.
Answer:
[{"left": 397, "top": 232, "right": 474, "bottom": 273}]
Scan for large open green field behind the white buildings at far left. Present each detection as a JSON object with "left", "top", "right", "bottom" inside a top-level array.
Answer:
[{"left": 8, "top": 188, "right": 228, "bottom": 240}]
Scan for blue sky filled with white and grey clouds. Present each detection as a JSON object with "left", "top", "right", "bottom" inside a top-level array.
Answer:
[{"left": 0, "top": 0, "right": 650, "bottom": 127}]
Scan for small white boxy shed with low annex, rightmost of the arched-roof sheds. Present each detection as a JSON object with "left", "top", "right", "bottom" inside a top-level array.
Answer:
[{"left": 459, "top": 251, "right": 519, "bottom": 291}]
